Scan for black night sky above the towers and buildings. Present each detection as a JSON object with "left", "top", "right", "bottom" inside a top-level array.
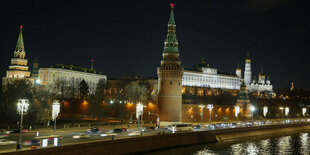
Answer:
[{"left": 0, "top": 0, "right": 310, "bottom": 89}]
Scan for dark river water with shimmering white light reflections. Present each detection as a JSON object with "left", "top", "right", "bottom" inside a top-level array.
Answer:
[{"left": 148, "top": 133, "right": 310, "bottom": 155}]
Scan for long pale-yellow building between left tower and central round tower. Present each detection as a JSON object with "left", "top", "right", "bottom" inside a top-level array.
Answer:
[{"left": 39, "top": 64, "right": 107, "bottom": 94}]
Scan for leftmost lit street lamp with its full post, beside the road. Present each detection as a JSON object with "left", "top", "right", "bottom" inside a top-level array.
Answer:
[{"left": 16, "top": 99, "right": 29, "bottom": 150}]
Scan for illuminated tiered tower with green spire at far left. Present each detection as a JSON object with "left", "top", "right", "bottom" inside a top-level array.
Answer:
[{"left": 2, "top": 25, "right": 33, "bottom": 85}]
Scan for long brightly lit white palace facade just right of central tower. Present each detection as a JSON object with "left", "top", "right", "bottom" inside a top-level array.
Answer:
[{"left": 182, "top": 58, "right": 240, "bottom": 89}]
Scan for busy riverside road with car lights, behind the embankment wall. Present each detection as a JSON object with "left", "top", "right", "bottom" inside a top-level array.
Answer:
[{"left": 0, "top": 119, "right": 310, "bottom": 153}]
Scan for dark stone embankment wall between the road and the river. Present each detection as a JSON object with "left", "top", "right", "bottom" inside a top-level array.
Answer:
[{"left": 7, "top": 123, "right": 310, "bottom": 155}]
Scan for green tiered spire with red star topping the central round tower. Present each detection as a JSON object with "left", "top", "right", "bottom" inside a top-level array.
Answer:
[{"left": 164, "top": 3, "right": 179, "bottom": 54}]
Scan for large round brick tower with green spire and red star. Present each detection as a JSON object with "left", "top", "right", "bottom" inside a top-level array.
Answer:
[{"left": 157, "top": 3, "right": 184, "bottom": 124}]
